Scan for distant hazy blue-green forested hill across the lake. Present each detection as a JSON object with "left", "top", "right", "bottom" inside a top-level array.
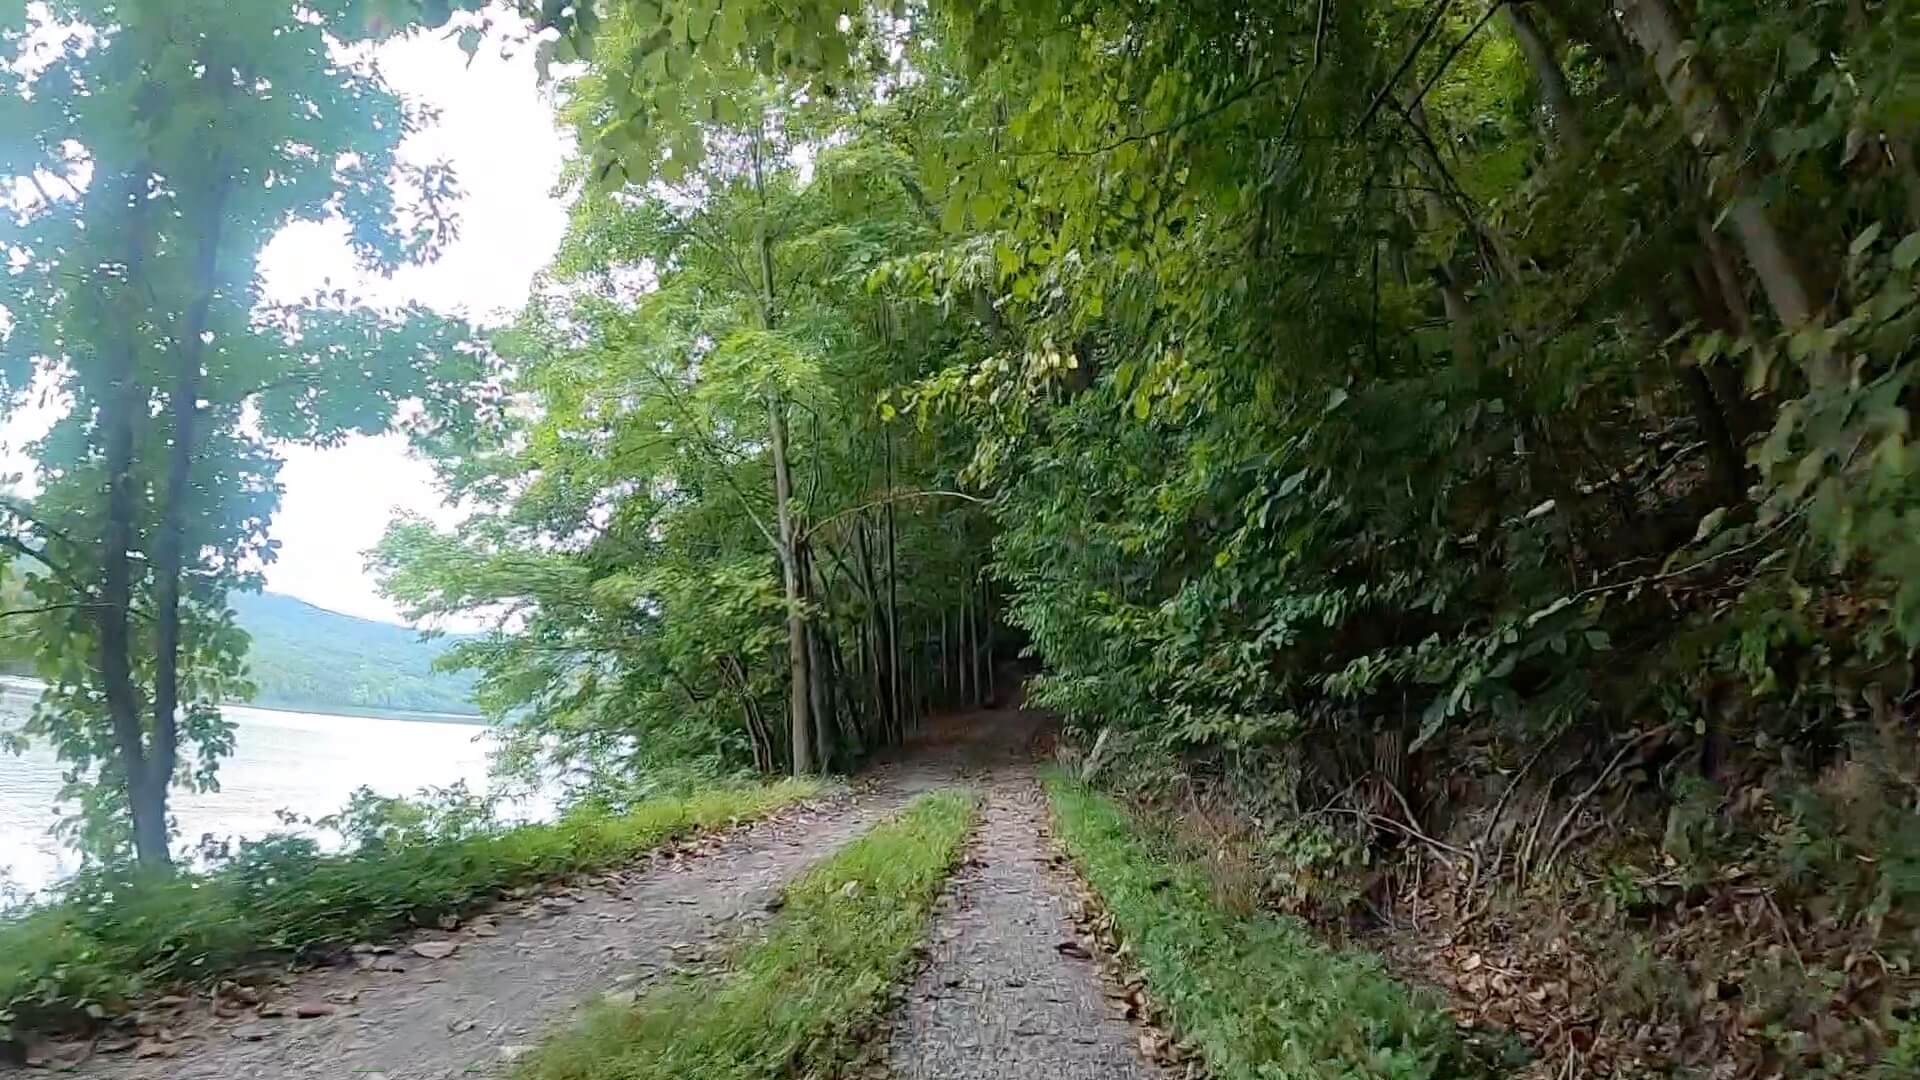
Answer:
[{"left": 230, "top": 592, "right": 474, "bottom": 713}]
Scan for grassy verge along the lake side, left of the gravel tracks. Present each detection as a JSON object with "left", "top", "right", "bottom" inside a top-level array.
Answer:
[{"left": 0, "top": 780, "right": 820, "bottom": 1042}]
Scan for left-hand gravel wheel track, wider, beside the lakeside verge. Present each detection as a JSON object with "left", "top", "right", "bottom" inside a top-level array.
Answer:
[{"left": 30, "top": 776, "right": 920, "bottom": 1080}]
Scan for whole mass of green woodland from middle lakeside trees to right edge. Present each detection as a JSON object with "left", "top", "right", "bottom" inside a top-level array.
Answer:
[{"left": 370, "top": 0, "right": 1920, "bottom": 1072}]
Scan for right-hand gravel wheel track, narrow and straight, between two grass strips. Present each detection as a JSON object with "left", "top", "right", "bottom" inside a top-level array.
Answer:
[{"left": 889, "top": 765, "right": 1162, "bottom": 1080}]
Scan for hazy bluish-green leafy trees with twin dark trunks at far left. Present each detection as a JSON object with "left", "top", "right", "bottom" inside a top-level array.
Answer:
[{"left": 0, "top": 0, "right": 478, "bottom": 865}]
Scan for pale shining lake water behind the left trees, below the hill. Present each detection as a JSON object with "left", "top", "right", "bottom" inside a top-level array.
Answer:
[{"left": 0, "top": 676, "right": 492, "bottom": 890}]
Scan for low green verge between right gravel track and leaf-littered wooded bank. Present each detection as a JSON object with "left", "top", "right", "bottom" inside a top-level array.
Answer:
[{"left": 1046, "top": 774, "right": 1482, "bottom": 1080}]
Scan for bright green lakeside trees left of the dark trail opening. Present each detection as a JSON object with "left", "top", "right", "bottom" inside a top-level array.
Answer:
[{"left": 376, "top": 27, "right": 989, "bottom": 771}]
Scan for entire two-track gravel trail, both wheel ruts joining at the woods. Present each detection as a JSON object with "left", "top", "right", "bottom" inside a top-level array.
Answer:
[{"left": 15, "top": 711, "right": 1156, "bottom": 1080}]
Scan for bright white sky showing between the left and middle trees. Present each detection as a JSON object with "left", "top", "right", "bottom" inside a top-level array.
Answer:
[{"left": 0, "top": 16, "right": 570, "bottom": 623}]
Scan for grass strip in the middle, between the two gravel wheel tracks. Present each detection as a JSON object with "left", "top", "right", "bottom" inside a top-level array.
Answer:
[{"left": 516, "top": 780, "right": 973, "bottom": 1080}]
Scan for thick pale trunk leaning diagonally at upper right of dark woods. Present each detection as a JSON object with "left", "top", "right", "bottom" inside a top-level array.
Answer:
[{"left": 1622, "top": 0, "right": 1841, "bottom": 353}]
